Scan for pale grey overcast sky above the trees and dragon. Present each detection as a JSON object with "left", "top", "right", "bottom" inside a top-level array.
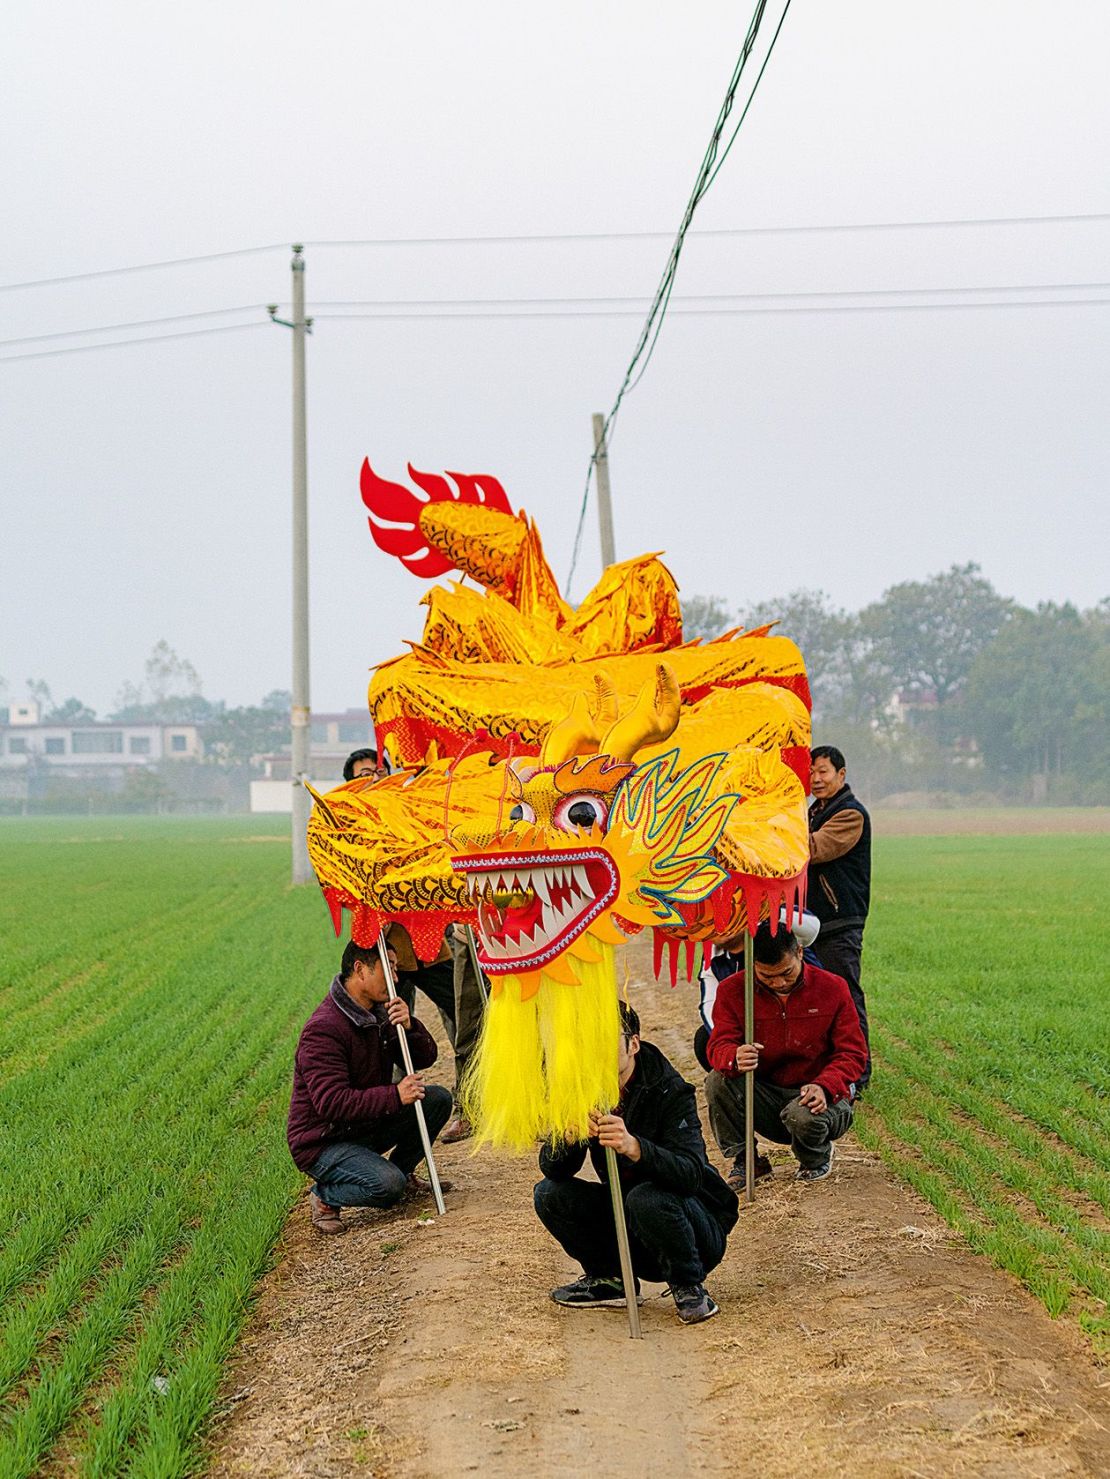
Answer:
[{"left": 0, "top": 0, "right": 1110, "bottom": 711}]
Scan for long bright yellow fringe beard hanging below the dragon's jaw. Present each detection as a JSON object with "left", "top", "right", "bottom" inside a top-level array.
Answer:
[{"left": 463, "top": 936, "right": 621, "bottom": 1151}]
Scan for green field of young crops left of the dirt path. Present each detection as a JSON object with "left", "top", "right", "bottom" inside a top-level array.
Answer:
[{"left": 0, "top": 819, "right": 336, "bottom": 1479}]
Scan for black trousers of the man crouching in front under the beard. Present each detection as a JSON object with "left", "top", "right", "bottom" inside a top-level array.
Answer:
[{"left": 534, "top": 1177, "right": 726, "bottom": 1288}]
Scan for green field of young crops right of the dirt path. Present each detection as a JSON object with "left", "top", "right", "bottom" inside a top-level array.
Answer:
[{"left": 856, "top": 836, "right": 1110, "bottom": 1355}]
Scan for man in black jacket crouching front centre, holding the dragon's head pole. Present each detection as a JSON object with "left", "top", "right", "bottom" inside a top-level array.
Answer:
[{"left": 535, "top": 1004, "right": 738, "bottom": 1325}]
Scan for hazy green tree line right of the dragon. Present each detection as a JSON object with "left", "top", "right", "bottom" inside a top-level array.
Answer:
[{"left": 683, "top": 565, "right": 1110, "bottom": 805}]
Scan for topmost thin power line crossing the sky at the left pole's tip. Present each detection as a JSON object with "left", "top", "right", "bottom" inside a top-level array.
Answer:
[{"left": 0, "top": 210, "right": 1110, "bottom": 293}]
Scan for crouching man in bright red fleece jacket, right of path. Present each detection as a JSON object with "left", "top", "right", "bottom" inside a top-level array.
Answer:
[{"left": 705, "top": 924, "right": 868, "bottom": 1188}]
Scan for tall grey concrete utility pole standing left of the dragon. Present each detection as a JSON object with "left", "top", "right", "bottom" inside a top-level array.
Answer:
[{"left": 290, "top": 246, "right": 313, "bottom": 883}]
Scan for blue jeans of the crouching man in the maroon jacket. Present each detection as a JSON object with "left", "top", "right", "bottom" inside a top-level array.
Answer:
[{"left": 310, "top": 1084, "right": 454, "bottom": 1207}]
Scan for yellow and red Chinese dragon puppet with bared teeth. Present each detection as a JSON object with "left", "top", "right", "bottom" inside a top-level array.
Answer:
[{"left": 309, "top": 461, "right": 810, "bottom": 1149}]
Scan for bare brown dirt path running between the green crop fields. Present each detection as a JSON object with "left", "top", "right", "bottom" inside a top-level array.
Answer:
[{"left": 211, "top": 951, "right": 1110, "bottom": 1479}]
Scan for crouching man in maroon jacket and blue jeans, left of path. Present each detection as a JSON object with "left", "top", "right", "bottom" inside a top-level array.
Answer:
[{"left": 285, "top": 941, "right": 452, "bottom": 1233}]
